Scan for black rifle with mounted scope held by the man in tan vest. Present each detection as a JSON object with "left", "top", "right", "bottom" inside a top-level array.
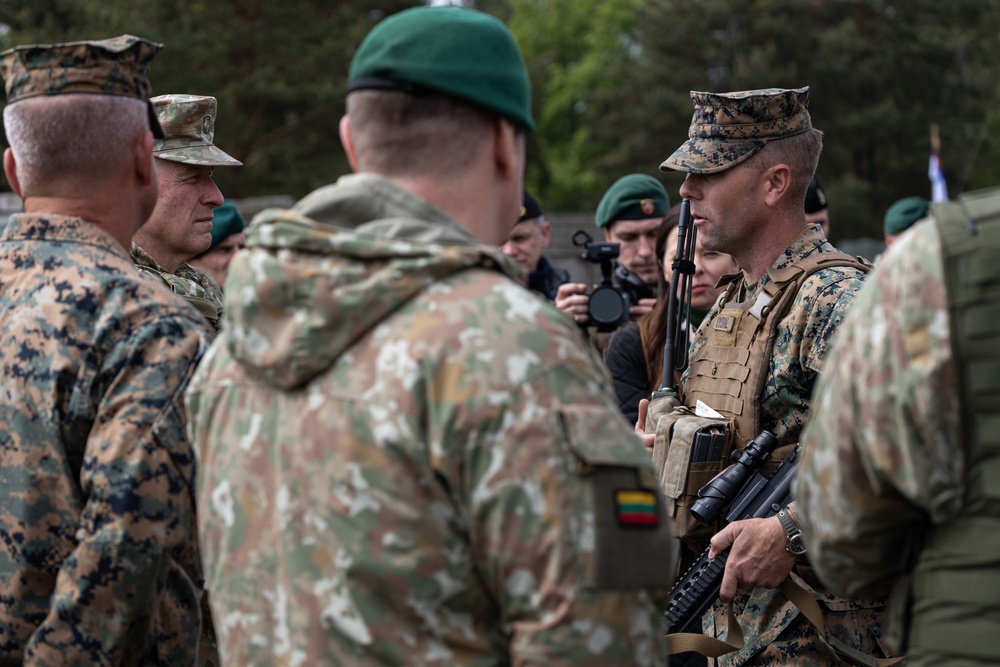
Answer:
[{"left": 663, "top": 431, "right": 801, "bottom": 633}]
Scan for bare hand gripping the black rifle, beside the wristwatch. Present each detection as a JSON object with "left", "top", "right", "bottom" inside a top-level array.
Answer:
[{"left": 709, "top": 517, "right": 795, "bottom": 602}]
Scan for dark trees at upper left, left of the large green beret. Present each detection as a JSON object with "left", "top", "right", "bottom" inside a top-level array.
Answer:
[{"left": 0, "top": 0, "right": 422, "bottom": 197}]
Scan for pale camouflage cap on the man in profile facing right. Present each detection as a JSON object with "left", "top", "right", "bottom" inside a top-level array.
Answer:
[{"left": 152, "top": 95, "right": 243, "bottom": 167}]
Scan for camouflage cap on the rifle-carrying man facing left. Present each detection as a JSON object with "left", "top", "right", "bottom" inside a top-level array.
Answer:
[{"left": 660, "top": 86, "right": 812, "bottom": 174}]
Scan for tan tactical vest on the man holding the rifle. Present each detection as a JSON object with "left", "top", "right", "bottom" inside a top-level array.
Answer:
[{"left": 684, "top": 252, "right": 871, "bottom": 444}]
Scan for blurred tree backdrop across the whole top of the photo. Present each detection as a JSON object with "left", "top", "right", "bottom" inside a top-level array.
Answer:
[{"left": 0, "top": 0, "right": 1000, "bottom": 255}]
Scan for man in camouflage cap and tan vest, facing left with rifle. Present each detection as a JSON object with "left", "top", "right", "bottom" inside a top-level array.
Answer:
[{"left": 640, "top": 88, "right": 884, "bottom": 665}]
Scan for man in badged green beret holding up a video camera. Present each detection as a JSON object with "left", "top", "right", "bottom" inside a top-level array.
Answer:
[{"left": 555, "top": 174, "right": 670, "bottom": 326}]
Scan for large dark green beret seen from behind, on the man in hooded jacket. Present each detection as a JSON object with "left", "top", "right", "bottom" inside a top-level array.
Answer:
[{"left": 347, "top": 7, "right": 535, "bottom": 132}]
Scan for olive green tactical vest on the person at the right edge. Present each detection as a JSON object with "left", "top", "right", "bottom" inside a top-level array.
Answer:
[{"left": 908, "top": 189, "right": 1000, "bottom": 665}]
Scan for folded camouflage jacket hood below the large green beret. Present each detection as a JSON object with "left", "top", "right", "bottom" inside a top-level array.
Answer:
[{"left": 223, "top": 174, "right": 520, "bottom": 389}]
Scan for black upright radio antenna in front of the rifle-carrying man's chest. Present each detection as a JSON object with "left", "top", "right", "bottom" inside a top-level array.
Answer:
[{"left": 652, "top": 199, "right": 698, "bottom": 399}]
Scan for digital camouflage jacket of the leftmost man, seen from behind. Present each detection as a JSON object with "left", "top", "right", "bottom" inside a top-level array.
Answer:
[{"left": 0, "top": 214, "right": 205, "bottom": 665}]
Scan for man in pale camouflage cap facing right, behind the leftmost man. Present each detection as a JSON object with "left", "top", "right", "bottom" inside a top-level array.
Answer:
[{"left": 132, "top": 95, "right": 243, "bottom": 334}]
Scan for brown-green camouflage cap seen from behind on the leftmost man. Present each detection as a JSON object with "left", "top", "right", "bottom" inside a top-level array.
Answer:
[{"left": 0, "top": 35, "right": 163, "bottom": 138}]
